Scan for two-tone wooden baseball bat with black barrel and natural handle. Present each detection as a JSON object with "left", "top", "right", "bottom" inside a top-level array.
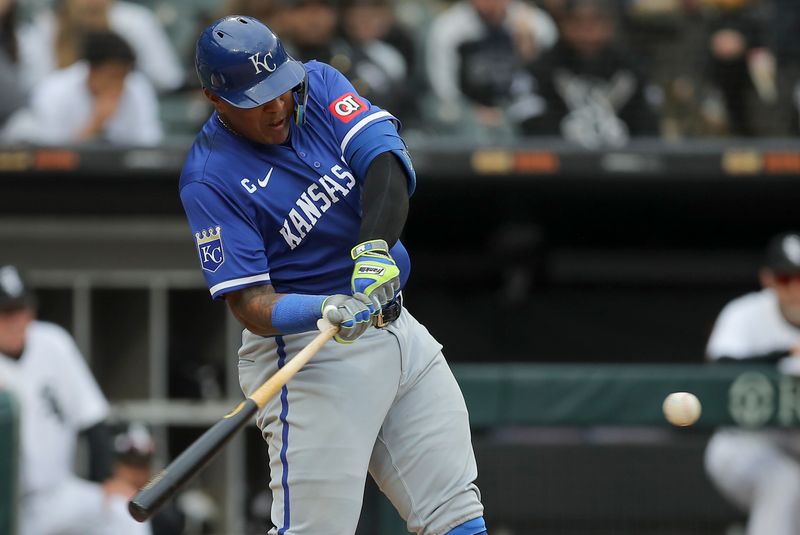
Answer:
[{"left": 128, "top": 324, "right": 338, "bottom": 522}]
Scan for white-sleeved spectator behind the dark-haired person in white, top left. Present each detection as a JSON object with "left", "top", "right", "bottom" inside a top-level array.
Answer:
[{"left": 20, "top": 0, "right": 184, "bottom": 92}]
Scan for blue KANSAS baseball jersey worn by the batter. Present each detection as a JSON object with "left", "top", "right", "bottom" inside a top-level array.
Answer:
[{"left": 180, "top": 61, "right": 413, "bottom": 298}]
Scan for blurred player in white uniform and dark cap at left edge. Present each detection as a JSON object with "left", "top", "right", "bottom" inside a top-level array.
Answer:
[{"left": 0, "top": 266, "right": 150, "bottom": 535}]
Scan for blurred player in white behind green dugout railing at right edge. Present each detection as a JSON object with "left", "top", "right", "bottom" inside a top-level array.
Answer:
[{"left": 706, "top": 233, "right": 800, "bottom": 535}]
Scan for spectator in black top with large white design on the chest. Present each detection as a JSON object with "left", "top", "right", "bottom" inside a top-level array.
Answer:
[{"left": 521, "top": 0, "right": 658, "bottom": 148}]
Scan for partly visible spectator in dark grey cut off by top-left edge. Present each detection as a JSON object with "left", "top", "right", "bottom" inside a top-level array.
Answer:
[{"left": 0, "top": 0, "right": 25, "bottom": 127}]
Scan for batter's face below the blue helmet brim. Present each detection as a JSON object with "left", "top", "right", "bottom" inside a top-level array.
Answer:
[{"left": 206, "top": 91, "right": 294, "bottom": 145}]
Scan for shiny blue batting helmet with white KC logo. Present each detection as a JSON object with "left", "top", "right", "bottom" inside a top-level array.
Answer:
[{"left": 195, "top": 15, "right": 307, "bottom": 119}]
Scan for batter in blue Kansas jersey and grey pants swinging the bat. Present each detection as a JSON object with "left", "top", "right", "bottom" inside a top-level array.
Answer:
[{"left": 180, "top": 16, "right": 486, "bottom": 535}]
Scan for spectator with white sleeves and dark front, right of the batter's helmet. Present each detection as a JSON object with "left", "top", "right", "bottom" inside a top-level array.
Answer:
[{"left": 425, "top": 0, "right": 558, "bottom": 133}]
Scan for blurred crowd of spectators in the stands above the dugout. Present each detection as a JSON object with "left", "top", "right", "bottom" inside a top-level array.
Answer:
[{"left": 0, "top": 0, "right": 800, "bottom": 148}]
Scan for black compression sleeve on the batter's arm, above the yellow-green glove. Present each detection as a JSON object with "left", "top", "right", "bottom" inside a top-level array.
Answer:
[{"left": 358, "top": 152, "right": 408, "bottom": 247}]
